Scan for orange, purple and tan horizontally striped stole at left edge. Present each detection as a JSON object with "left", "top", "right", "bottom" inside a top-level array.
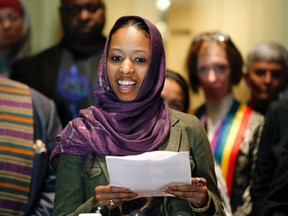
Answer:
[{"left": 0, "top": 77, "right": 35, "bottom": 215}]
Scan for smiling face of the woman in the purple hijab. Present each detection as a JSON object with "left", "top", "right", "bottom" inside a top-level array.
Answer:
[{"left": 107, "top": 26, "right": 150, "bottom": 102}]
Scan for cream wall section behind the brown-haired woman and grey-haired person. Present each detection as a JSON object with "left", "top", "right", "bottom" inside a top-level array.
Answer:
[{"left": 166, "top": 0, "right": 288, "bottom": 108}]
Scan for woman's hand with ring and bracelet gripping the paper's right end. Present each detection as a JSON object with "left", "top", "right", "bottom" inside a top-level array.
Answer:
[{"left": 164, "top": 177, "right": 209, "bottom": 208}]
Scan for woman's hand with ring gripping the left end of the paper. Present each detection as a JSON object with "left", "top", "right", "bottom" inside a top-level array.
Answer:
[{"left": 93, "top": 185, "right": 138, "bottom": 210}]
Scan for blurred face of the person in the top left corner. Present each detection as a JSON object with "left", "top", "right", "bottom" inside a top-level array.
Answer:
[{"left": 0, "top": 7, "right": 24, "bottom": 47}]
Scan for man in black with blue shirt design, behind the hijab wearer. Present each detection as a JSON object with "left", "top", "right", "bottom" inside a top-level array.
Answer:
[{"left": 11, "top": 0, "right": 106, "bottom": 125}]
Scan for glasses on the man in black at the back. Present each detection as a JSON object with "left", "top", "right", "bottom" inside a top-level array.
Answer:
[{"left": 61, "top": 3, "right": 104, "bottom": 16}]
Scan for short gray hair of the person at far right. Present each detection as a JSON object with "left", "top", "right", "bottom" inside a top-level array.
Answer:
[{"left": 247, "top": 42, "right": 288, "bottom": 73}]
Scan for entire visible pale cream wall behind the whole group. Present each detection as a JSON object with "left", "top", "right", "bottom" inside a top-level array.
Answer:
[{"left": 22, "top": 0, "right": 288, "bottom": 108}]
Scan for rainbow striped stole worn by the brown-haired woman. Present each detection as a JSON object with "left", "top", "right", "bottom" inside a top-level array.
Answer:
[{"left": 195, "top": 101, "right": 252, "bottom": 196}]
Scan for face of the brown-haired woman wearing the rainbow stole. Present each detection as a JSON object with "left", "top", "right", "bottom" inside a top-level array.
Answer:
[{"left": 197, "top": 43, "right": 232, "bottom": 100}]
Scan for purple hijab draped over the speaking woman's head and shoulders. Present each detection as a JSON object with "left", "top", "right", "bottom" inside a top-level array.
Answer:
[{"left": 51, "top": 16, "right": 170, "bottom": 162}]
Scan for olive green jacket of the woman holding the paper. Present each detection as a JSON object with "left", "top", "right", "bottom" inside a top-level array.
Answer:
[{"left": 53, "top": 110, "right": 225, "bottom": 216}]
